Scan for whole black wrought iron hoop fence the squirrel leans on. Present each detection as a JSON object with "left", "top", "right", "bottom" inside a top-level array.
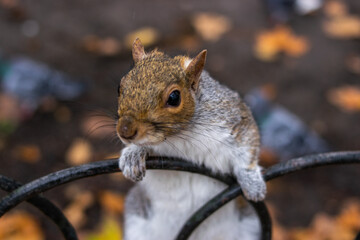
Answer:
[{"left": 0, "top": 151, "right": 360, "bottom": 240}]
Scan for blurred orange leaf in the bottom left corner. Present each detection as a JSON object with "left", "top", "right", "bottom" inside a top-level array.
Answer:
[{"left": 0, "top": 211, "right": 45, "bottom": 240}]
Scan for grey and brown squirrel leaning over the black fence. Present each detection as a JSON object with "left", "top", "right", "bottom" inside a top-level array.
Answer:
[{"left": 116, "top": 39, "right": 266, "bottom": 240}]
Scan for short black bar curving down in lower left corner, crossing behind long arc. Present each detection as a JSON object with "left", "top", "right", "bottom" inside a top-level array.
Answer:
[{"left": 0, "top": 175, "right": 78, "bottom": 240}]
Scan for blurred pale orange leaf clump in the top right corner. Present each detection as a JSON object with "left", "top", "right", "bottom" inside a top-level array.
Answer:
[{"left": 323, "top": 1, "right": 360, "bottom": 39}]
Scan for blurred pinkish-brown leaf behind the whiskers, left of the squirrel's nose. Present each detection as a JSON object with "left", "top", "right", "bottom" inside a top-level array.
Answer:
[{"left": 81, "top": 113, "right": 116, "bottom": 138}]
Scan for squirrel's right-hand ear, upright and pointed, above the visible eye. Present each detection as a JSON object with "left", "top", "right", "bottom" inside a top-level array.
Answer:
[{"left": 185, "top": 50, "right": 207, "bottom": 92}]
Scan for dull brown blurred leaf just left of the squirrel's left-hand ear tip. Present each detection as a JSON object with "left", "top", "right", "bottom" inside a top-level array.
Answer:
[{"left": 83, "top": 35, "right": 121, "bottom": 56}]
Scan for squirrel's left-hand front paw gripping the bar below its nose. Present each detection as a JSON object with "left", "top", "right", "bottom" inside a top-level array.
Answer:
[{"left": 119, "top": 146, "right": 147, "bottom": 182}]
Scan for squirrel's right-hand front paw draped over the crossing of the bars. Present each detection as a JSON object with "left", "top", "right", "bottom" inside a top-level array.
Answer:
[{"left": 236, "top": 168, "right": 266, "bottom": 202}]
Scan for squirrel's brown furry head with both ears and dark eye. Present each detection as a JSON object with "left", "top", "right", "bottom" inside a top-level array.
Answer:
[{"left": 116, "top": 39, "right": 206, "bottom": 145}]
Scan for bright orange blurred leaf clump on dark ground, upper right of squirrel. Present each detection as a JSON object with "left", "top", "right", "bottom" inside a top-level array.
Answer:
[{"left": 254, "top": 26, "right": 309, "bottom": 61}]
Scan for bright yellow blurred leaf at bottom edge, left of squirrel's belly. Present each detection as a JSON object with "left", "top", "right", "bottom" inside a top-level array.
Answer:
[{"left": 85, "top": 217, "right": 122, "bottom": 240}]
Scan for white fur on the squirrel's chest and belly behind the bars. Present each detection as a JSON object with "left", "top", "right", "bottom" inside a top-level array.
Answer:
[{"left": 125, "top": 128, "right": 259, "bottom": 240}]
